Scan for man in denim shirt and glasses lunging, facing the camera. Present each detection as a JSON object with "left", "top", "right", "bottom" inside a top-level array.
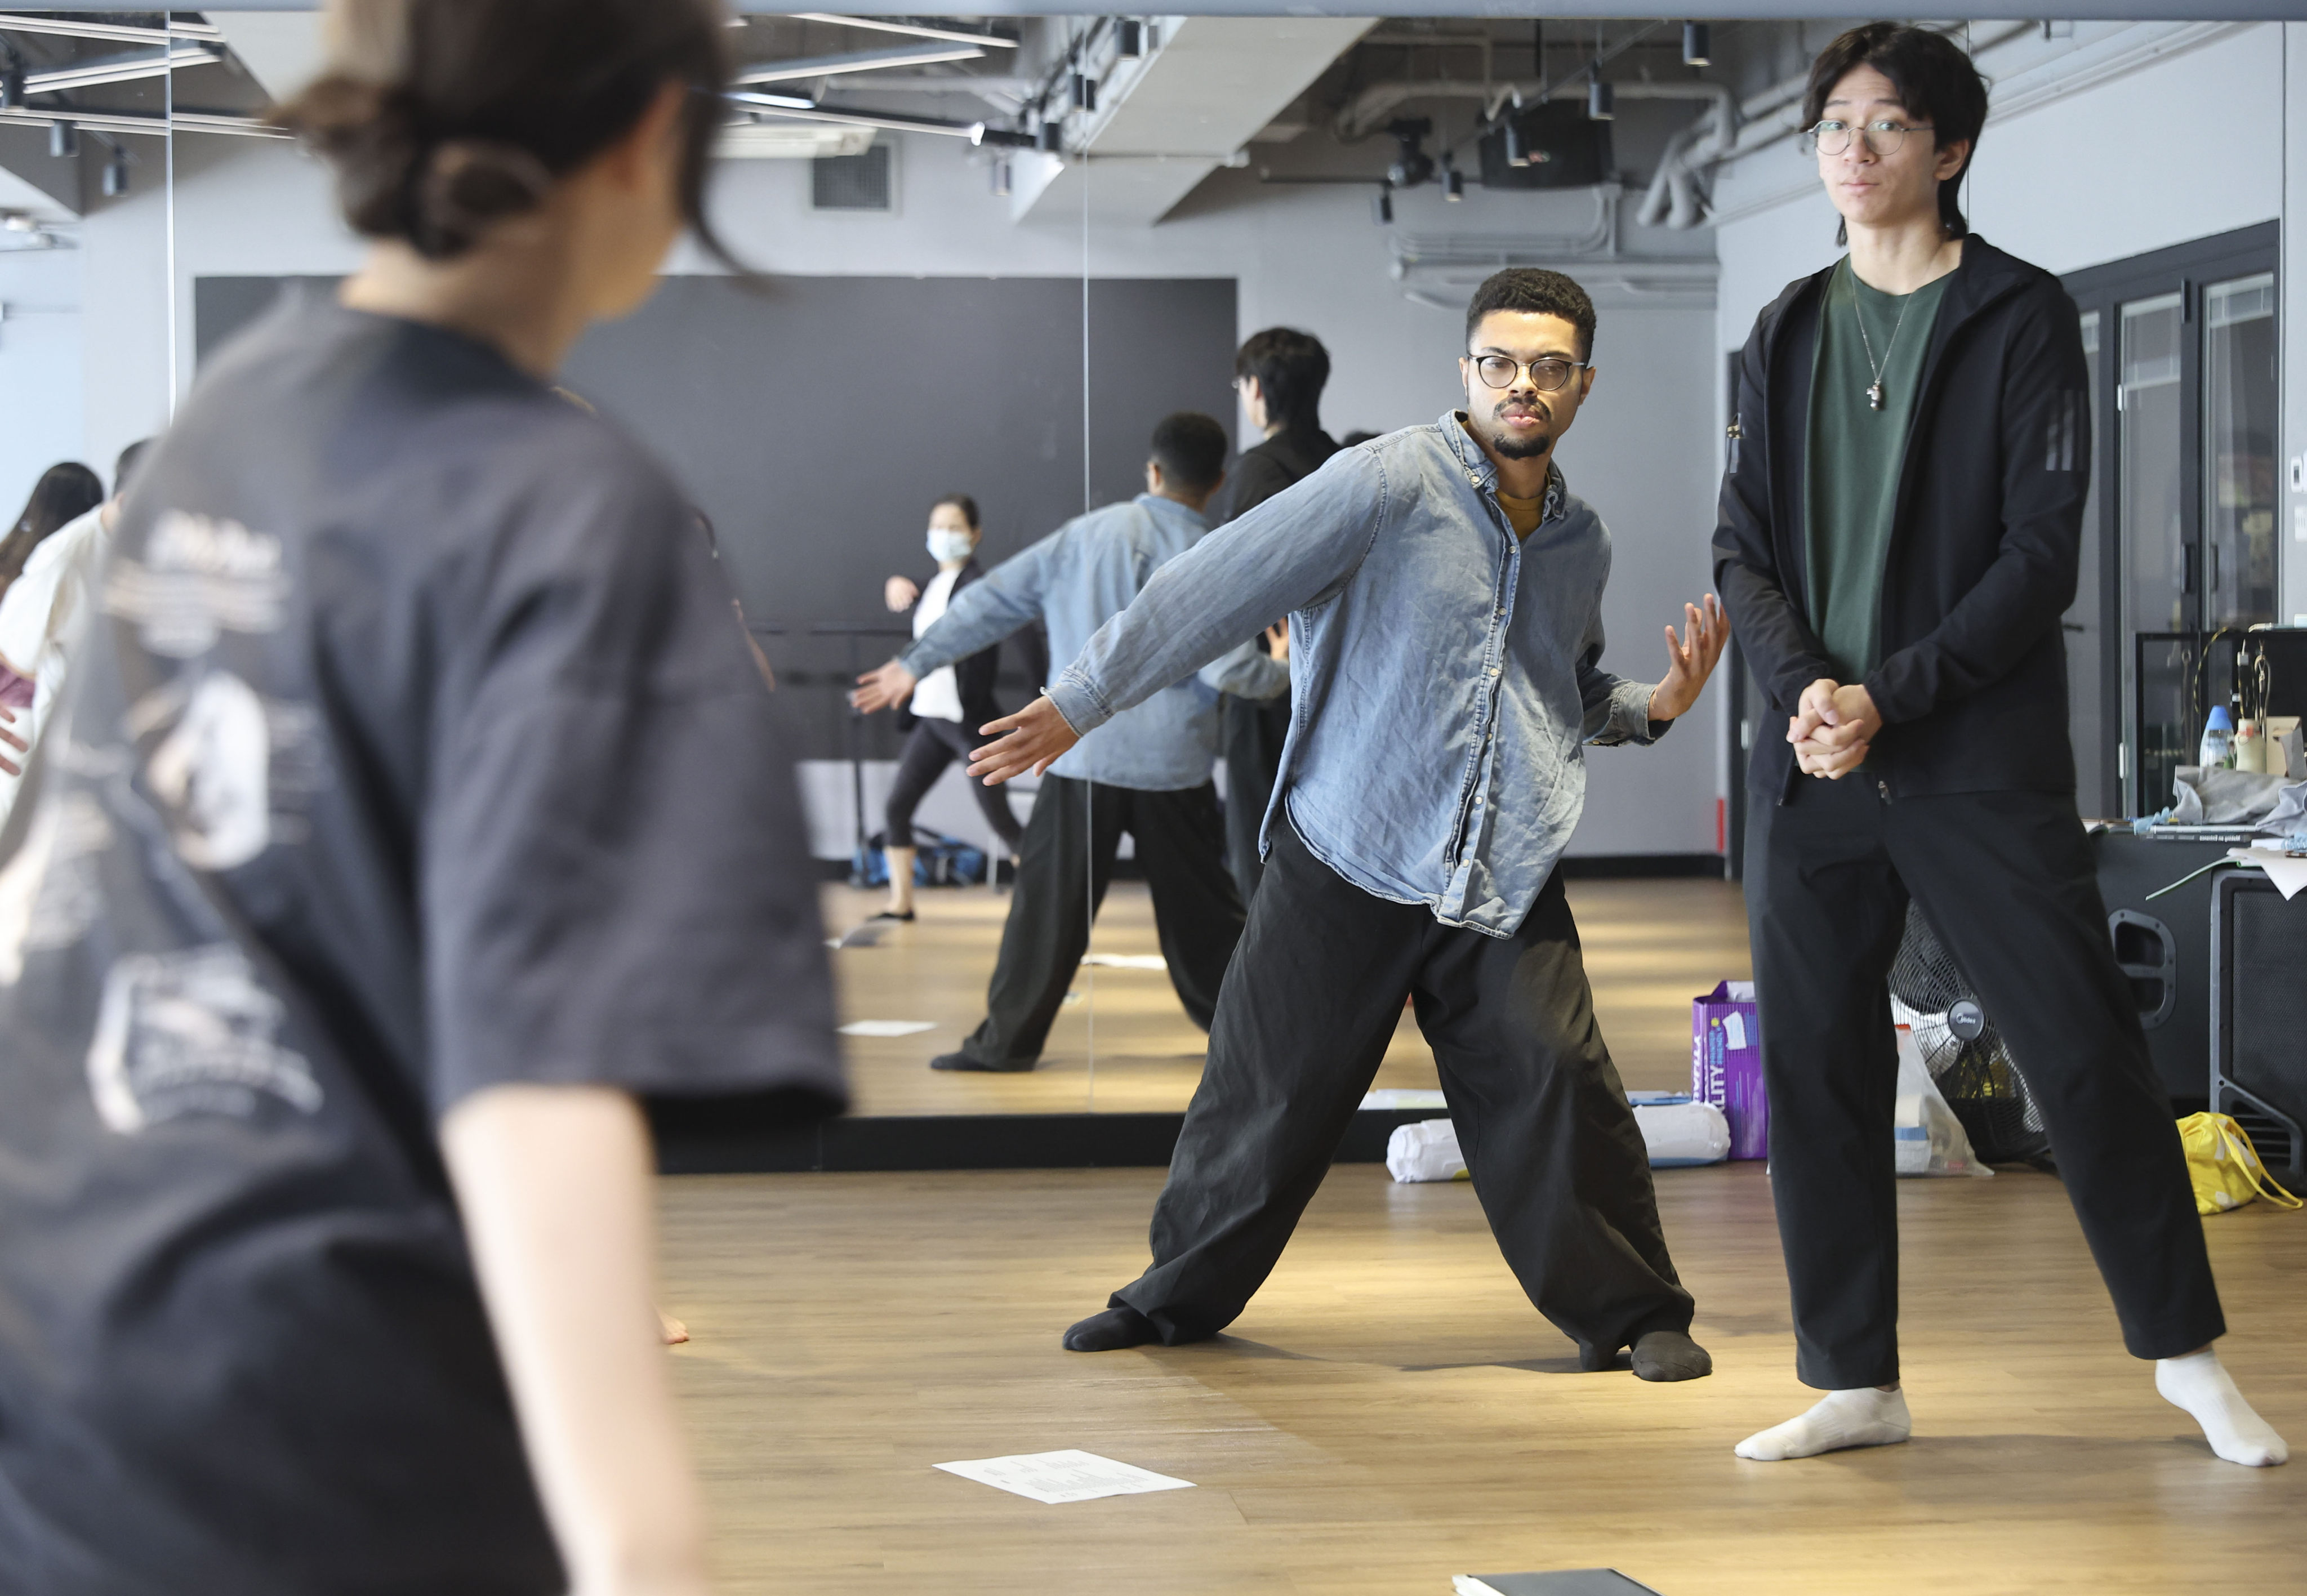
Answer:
[{"left": 971, "top": 270, "right": 1726, "bottom": 1379}]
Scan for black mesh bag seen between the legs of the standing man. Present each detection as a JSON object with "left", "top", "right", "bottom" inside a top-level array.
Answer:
[{"left": 1890, "top": 902, "right": 2051, "bottom": 1169}]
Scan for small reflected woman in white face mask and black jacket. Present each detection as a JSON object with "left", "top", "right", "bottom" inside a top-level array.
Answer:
[{"left": 874, "top": 493, "right": 1022, "bottom": 920}]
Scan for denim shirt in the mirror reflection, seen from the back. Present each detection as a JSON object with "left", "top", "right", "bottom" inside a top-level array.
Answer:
[{"left": 897, "top": 493, "right": 1290, "bottom": 791}]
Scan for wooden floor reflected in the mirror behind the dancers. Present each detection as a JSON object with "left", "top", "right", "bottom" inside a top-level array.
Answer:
[{"left": 823, "top": 881, "right": 1749, "bottom": 1114}]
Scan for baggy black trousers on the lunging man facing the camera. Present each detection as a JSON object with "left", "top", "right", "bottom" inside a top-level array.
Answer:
[{"left": 1112, "top": 823, "right": 1691, "bottom": 1352}]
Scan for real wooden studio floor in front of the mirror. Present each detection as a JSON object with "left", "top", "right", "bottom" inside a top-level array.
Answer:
[{"left": 665, "top": 1165, "right": 2307, "bottom": 1596}]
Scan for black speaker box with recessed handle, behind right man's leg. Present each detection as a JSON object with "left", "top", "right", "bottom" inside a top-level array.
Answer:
[{"left": 2090, "top": 830, "right": 2235, "bottom": 1114}]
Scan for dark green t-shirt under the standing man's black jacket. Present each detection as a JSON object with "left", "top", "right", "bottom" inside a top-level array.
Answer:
[{"left": 1804, "top": 256, "right": 1947, "bottom": 683}]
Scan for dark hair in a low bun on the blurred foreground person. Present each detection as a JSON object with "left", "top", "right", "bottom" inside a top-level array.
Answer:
[{"left": 272, "top": 0, "right": 729, "bottom": 261}]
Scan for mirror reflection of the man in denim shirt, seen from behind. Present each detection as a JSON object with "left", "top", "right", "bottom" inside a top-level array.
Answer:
[{"left": 854, "top": 411, "right": 1290, "bottom": 1072}]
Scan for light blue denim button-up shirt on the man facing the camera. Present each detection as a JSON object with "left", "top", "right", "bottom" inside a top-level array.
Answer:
[{"left": 1047, "top": 413, "right": 1665, "bottom": 937}]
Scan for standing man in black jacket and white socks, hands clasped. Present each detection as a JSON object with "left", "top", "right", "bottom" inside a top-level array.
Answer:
[{"left": 1714, "top": 23, "right": 2286, "bottom": 1465}]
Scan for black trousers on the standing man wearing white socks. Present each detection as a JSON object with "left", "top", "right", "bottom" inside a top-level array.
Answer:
[{"left": 1747, "top": 773, "right": 2226, "bottom": 1391}]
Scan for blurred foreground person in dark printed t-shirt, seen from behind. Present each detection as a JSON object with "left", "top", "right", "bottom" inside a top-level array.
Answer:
[{"left": 0, "top": 0, "right": 840, "bottom": 1596}]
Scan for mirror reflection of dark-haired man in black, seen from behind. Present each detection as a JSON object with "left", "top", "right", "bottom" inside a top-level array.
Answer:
[{"left": 1209, "top": 328, "right": 1338, "bottom": 904}]
